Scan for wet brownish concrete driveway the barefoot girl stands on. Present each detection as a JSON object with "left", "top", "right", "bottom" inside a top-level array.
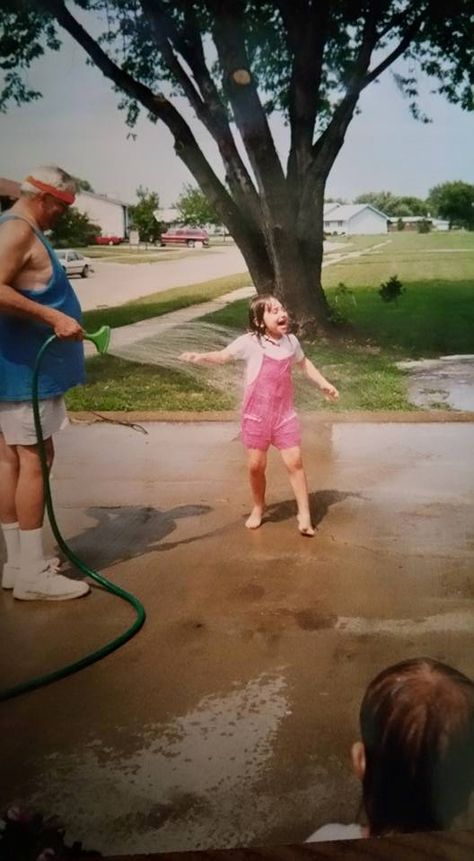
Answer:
[{"left": 0, "top": 416, "right": 474, "bottom": 854}]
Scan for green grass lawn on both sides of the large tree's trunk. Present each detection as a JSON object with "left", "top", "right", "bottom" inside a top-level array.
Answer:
[{"left": 68, "top": 232, "right": 474, "bottom": 413}]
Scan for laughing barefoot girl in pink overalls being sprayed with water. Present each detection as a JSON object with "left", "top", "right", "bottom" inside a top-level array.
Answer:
[{"left": 179, "top": 294, "right": 339, "bottom": 536}]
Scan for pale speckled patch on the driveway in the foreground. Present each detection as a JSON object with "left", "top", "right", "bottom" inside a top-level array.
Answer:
[{"left": 29, "top": 674, "right": 290, "bottom": 853}]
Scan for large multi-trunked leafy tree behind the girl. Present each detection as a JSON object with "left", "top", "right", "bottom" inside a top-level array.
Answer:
[{"left": 0, "top": 0, "right": 474, "bottom": 333}]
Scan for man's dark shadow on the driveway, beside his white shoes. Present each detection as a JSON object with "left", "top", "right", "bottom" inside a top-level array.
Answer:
[{"left": 63, "top": 505, "right": 212, "bottom": 569}]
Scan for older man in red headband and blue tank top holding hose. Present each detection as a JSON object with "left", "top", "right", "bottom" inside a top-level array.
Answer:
[{"left": 0, "top": 167, "right": 89, "bottom": 601}]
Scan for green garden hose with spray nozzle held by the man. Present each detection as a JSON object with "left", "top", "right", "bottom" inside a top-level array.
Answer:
[{"left": 0, "top": 326, "right": 146, "bottom": 702}]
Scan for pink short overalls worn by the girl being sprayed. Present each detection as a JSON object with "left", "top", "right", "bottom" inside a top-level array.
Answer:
[{"left": 241, "top": 356, "right": 301, "bottom": 451}]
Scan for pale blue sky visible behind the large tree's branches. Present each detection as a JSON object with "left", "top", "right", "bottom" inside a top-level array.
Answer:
[{"left": 0, "top": 21, "right": 474, "bottom": 207}]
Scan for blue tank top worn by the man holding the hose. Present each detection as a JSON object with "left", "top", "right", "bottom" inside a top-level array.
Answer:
[{"left": 0, "top": 214, "right": 85, "bottom": 401}]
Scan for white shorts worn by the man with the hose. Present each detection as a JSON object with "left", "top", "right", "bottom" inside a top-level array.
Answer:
[{"left": 0, "top": 395, "right": 68, "bottom": 445}]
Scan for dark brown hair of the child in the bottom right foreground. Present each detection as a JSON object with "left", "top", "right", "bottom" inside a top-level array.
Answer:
[{"left": 360, "top": 658, "right": 474, "bottom": 834}]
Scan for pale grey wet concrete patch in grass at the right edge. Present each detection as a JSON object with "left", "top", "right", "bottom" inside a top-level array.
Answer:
[{"left": 397, "top": 355, "right": 474, "bottom": 412}]
